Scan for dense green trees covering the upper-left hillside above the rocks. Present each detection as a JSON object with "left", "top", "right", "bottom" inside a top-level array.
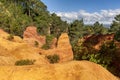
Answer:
[{"left": 0, "top": 0, "right": 68, "bottom": 37}]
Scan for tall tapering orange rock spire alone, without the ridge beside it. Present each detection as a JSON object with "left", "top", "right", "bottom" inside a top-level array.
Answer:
[{"left": 57, "top": 33, "right": 73, "bottom": 61}]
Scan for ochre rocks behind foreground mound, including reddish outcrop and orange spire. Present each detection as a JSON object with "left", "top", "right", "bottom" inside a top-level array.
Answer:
[{"left": 0, "top": 27, "right": 73, "bottom": 65}]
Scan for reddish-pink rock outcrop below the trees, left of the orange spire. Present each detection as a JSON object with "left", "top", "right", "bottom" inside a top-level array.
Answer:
[{"left": 23, "top": 26, "right": 46, "bottom": 47}]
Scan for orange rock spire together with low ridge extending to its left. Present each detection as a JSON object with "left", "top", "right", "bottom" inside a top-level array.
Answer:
[{"left": 40, "top": 33, "right": 73, "bottom": 62}]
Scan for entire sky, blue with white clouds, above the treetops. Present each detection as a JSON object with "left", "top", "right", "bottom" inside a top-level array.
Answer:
[{"left": 42, "top": 0, "right": 120, "bottom": 24}]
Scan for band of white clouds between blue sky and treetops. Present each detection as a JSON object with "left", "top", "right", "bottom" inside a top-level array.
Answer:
[{"left": 56, "top": 9, "right": 120, "bottom": 24}]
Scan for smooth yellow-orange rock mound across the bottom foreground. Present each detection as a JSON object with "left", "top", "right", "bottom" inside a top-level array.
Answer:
[{"left": 0, "top": 61, "right": 118, "bottom": 80}]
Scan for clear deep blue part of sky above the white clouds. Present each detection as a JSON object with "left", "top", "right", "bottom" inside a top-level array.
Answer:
[{"left": 42, "top": 0, "right": 120, "bottom": 12}]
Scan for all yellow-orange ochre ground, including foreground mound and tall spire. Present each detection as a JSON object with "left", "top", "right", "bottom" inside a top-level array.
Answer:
[{"left": 0, "top": 30, "right": 119, "bottom": 80}]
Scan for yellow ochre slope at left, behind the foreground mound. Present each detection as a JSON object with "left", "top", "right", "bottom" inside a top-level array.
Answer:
[{"left": 0, "top": 31, "right": 49, "bottom": 65}]
